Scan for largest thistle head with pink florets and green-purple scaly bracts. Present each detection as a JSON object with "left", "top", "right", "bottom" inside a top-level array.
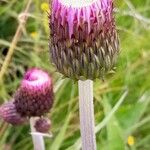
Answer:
[{"left": 50, "top": 0, "right": 119, "bottom": 80}]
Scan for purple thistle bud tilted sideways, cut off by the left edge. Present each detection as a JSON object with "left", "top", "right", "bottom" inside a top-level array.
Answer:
[{"left": 0, "top": 101, "right": 27, "bottom": 125}]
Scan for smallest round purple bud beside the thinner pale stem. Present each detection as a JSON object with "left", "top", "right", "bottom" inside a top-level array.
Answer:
[{"left": 34, "top": 118, "right": 51, "bottom": 133}]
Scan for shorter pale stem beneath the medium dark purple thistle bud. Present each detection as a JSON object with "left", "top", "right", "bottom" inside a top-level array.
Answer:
[{"left": 30, "top": 117, "right": 45, "bottom": 150}]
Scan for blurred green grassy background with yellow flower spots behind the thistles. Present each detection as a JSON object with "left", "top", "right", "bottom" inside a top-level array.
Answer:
[{"left": 0, "top": 0, "right": 150, "bottom": 150}]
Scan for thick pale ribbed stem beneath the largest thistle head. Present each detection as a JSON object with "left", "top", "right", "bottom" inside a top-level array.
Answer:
[{"left": 78, "top": 80, "right": 96, "bottom": 150}]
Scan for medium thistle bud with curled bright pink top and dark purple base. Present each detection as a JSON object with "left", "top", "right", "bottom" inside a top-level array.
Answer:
[{"left": 14, "top": 69, "right": 53, "bottom": 117}]
